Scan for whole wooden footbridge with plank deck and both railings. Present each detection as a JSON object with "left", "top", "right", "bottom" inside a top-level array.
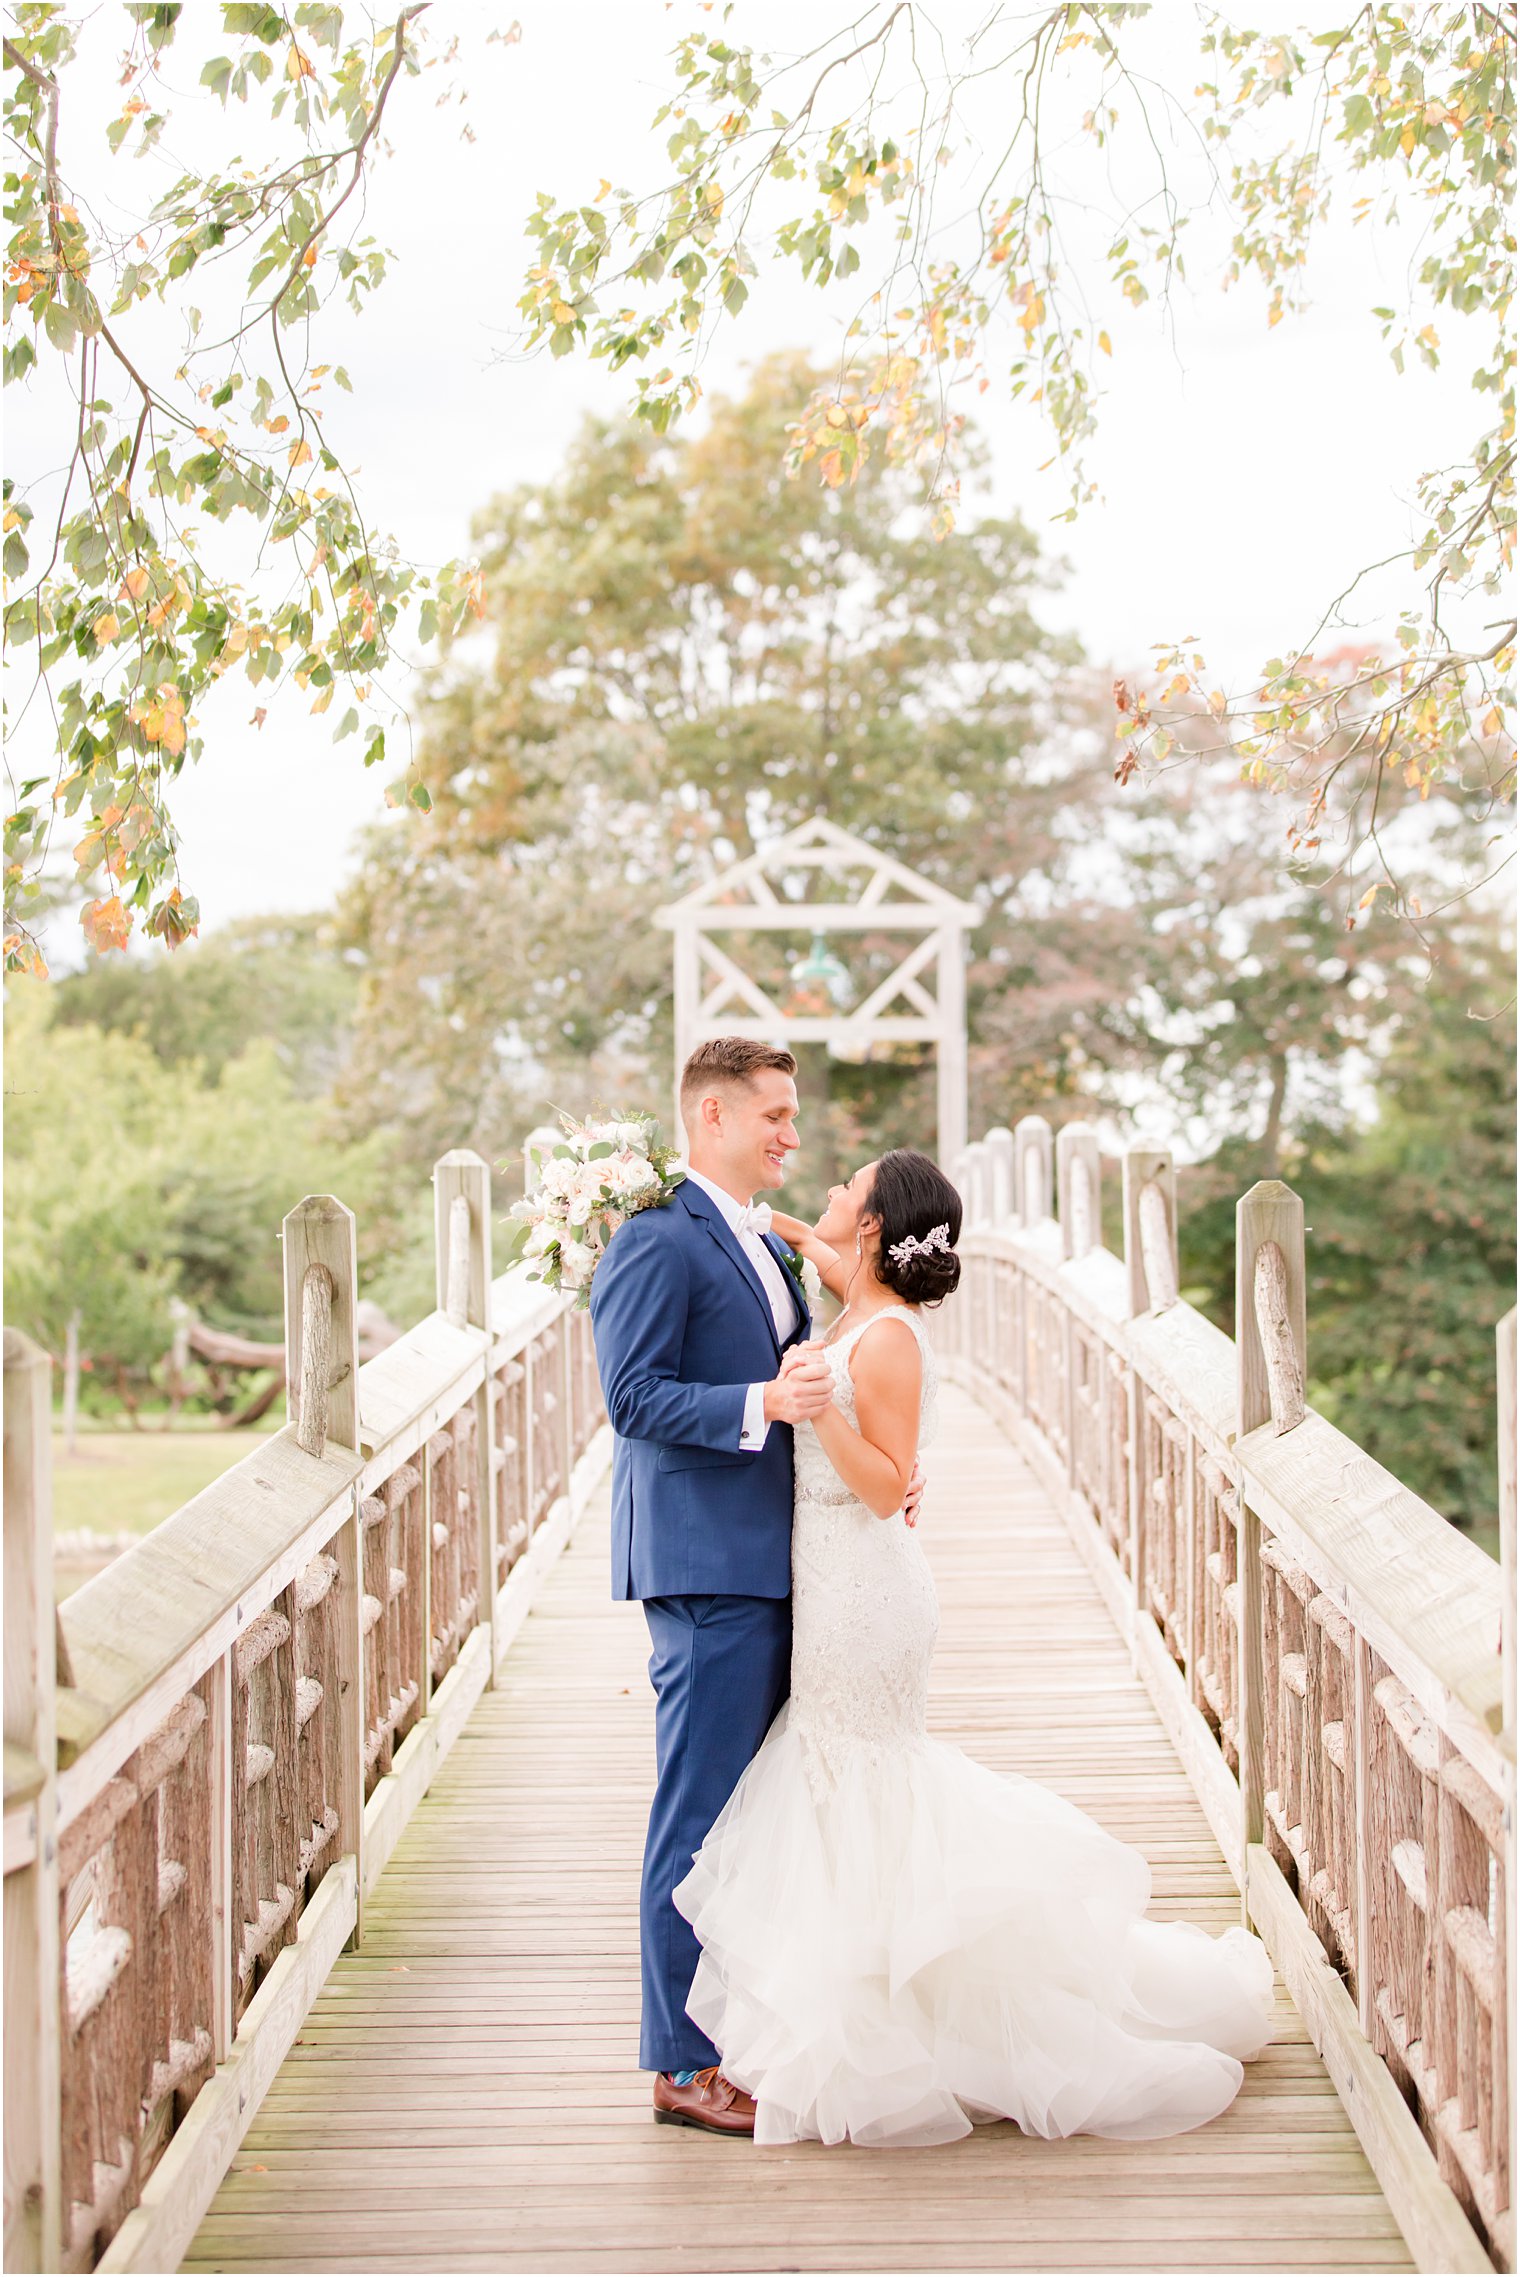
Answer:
[{"left": 5, "top": 1118, "right": 1515, "bottom": 2270}]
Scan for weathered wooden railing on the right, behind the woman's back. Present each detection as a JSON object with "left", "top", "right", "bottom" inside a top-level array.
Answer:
[{"left": 942, "top": 1116, "right": 1515, "bottom": 2270}]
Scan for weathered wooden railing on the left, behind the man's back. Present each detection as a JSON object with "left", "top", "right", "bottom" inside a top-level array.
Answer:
[{"left": 5, "top": 1152, "right": 608, "bottom": 2270}]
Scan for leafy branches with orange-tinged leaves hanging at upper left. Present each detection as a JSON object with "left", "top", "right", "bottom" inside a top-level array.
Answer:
[{"left": 5, "top": 0, "right": 478, "bottom": 972}]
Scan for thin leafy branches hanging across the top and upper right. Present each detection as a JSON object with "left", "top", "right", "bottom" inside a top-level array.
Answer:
[{"left": 519, "top": 0, "right": 1515, "bottom": 909}]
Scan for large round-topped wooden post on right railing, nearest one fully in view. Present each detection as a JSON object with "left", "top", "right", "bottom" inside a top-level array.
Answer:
[{"left": 1236, "top": 1177, "right": 1310, "bottom": 1922}]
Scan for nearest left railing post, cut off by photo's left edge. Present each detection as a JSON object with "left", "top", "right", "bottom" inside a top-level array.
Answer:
[{"left": 5, "top": 1327, "right": 64, "bottom": 2270}]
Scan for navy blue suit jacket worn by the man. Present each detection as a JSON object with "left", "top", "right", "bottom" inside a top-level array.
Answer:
[{"left": 592, "top": 1179, "right": 810, "bottom": 1598}]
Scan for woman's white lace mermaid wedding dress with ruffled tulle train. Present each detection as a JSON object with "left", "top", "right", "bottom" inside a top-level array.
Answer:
[{"left": 676, "top": 1307, "right": 1272, "bottom": 2143}]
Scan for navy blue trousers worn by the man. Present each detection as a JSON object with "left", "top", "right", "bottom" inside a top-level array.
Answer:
[{"left": 639, "top": 1596, "right": 792, "bottom": 2072}]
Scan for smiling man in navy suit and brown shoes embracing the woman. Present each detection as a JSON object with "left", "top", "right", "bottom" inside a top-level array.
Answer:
[{"left": 592, "top": 1036, "right": 851, "bottom": 2134}]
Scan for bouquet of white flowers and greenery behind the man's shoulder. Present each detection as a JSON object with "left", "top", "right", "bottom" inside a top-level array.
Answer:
[{"left": 505, "top": 1113, "right": 685, "bottom": 1312}]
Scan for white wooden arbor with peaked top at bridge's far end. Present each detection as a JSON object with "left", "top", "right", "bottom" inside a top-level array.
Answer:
[{"left": 655, "top": 815, "right": 981, "bottom": 1164}]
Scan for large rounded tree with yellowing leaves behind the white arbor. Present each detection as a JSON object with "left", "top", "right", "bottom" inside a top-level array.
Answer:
[{"left": 334, "top": 357, "right": 1108, "bottom": 1177}]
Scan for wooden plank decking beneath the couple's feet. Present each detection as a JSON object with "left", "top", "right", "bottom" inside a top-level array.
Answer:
[{"left": 184, "top": 1391, "right": 1411, "bottom": 2270}]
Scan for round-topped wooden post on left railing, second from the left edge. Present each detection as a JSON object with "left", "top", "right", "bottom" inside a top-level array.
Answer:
[{"left": 281, "top": 1193, "right": 364, "bottom": 1958}]
